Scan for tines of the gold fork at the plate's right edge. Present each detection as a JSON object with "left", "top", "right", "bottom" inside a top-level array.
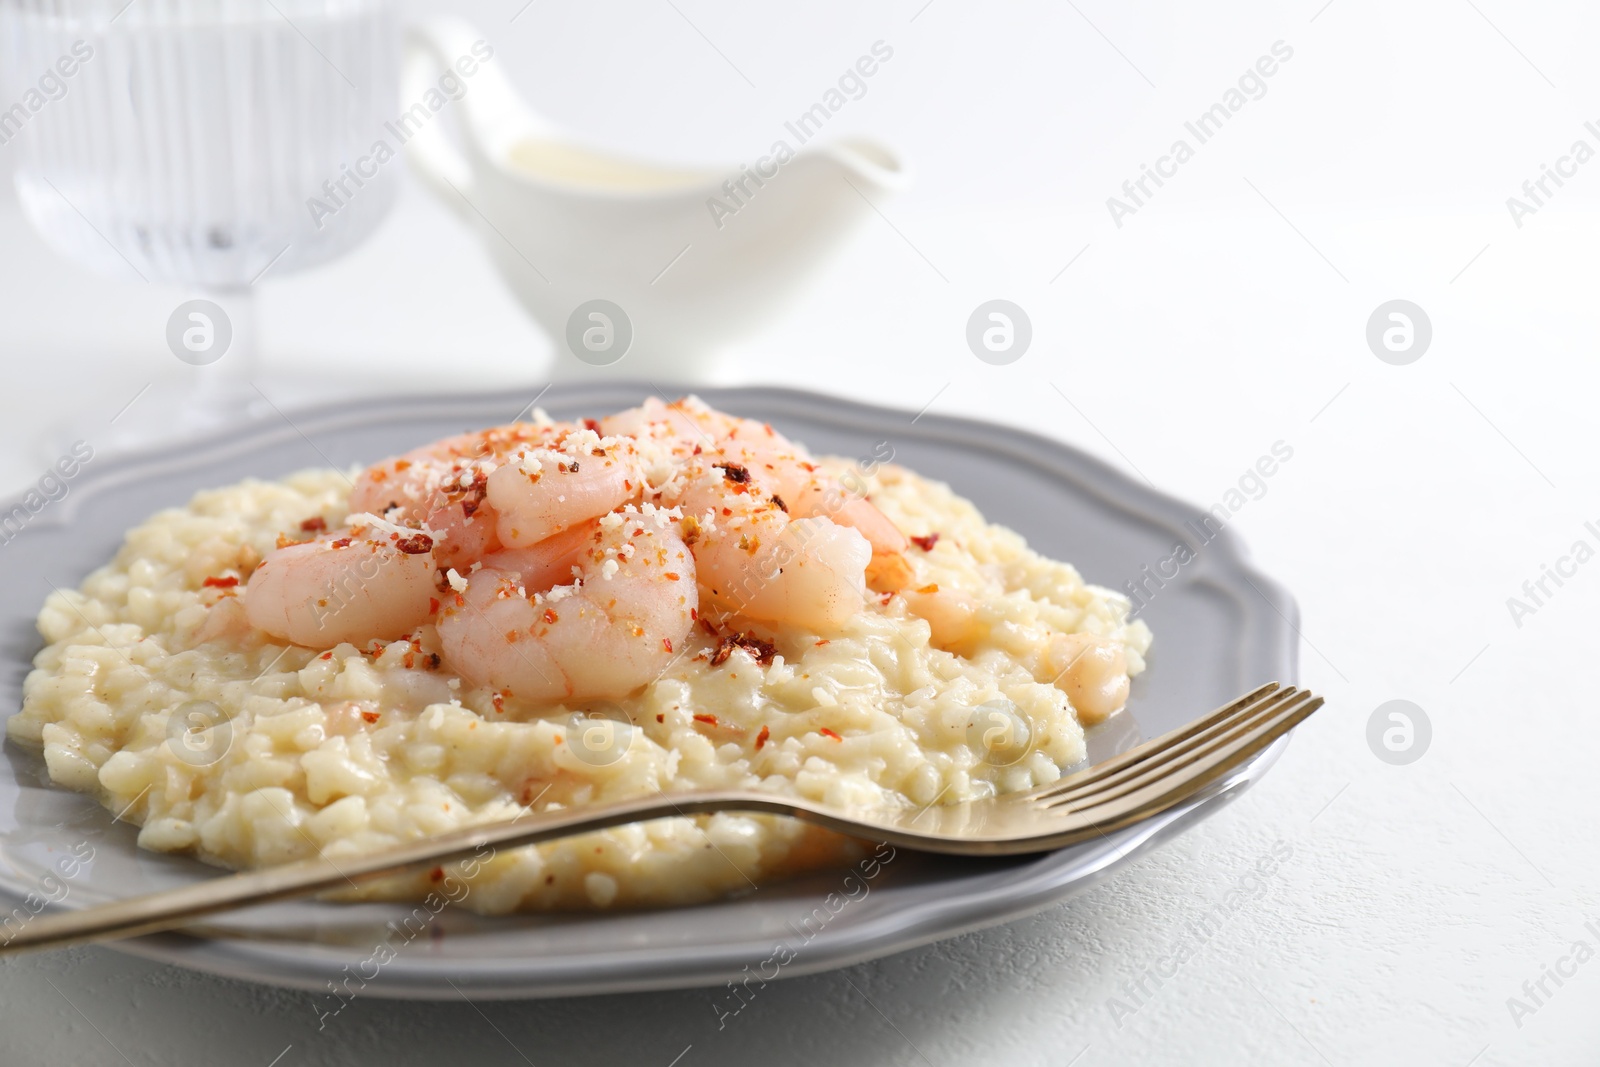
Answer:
[{"left": 1043, "top": 689, "right": 1322, "bottom": 822}]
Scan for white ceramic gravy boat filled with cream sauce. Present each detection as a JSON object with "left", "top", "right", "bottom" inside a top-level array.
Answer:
[{"left": 402, "top": 18, "right": 907, "bottom": 381}]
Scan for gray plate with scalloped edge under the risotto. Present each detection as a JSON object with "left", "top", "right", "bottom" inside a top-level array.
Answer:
[{"left": 0, "top": 384, "right": 1296, "bottom": 1005}]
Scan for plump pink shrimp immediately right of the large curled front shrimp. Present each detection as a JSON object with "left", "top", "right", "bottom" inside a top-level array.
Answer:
[{"left": 678, "top": 462, "right": 872, "bottom": 633}]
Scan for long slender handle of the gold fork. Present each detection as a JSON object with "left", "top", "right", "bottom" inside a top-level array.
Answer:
[{"left": 0, "top": 792, "right": 793, "bottom": 957}]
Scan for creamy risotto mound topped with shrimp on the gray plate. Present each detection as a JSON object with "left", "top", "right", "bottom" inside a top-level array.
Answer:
[{"left": 8, "top": 399, "right": 1150, "bottom": 913}]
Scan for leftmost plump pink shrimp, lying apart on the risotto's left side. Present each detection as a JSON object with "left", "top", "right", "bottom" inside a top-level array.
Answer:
[{"left": 245, "top": 515, "right": 437, "bottom": 648}]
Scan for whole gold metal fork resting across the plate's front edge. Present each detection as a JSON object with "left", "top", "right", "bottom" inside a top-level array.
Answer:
[{"left": 0, "top": 681, "right": 1322, "bottom": 957}]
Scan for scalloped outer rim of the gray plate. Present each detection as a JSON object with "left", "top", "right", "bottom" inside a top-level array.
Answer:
[{"left": 0, "top": 379, "right": 1299, "bottom": 1000}]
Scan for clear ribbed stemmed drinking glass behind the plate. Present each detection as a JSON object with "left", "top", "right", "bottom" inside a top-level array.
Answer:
[{"left": 0, "top": 0, "right": 402, "bottom": 443}]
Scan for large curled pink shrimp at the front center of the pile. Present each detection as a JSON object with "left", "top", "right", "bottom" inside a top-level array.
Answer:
[{"left": 437, "top": 504, "right": 698, "bottom": 702}]
